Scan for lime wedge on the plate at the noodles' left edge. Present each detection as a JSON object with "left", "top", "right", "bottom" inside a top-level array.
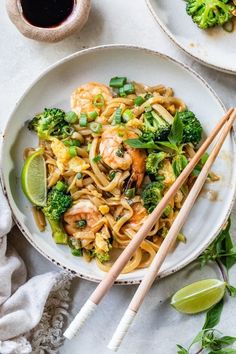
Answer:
[{"left": 21, "top": 149, "right": 47, "bottom": 206}]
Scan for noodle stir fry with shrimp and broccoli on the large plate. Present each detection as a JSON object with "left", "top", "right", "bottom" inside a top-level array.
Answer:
[{"left": 25, "top": 77, "right": 217, "bottom": 273}]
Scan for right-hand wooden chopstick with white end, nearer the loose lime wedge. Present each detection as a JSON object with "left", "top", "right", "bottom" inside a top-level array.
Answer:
[{"left": 108, "top": 109, "right": 236, "bottom": 351}]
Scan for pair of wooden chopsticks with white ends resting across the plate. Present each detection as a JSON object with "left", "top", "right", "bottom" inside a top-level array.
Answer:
[{"left": 64, "top": 108, "right": 236, "bottom": 351}]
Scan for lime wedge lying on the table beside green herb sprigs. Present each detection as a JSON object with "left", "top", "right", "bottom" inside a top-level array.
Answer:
[{"left": 171, "top": 279, "right": 226, "bottom": 313}]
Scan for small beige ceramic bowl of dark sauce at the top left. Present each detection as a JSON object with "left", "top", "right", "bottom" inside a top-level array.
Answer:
[{"left": 6, "top": 0, "right": 91, "bottom": 42}]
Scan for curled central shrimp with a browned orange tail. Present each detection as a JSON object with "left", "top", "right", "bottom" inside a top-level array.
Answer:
[{"left": 99, "top": 127, "right": 146, "bottom": 187}]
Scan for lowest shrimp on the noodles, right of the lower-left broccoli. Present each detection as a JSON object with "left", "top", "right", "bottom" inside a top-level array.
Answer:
[{"left": 64, "top": 199, "right": 102, "bottom": 237}]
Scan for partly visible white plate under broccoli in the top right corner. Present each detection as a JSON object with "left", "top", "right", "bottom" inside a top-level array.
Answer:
[{"left": 146, "top": 0, "right": 236, "bottom": 74}]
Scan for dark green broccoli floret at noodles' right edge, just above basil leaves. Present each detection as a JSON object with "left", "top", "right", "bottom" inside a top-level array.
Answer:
[{"left": 177, "top": 111, "right": 203, "bottom": 145}]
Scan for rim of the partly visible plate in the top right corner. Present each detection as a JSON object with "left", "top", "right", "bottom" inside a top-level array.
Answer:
[{"left": 145, "top": 0, "right": 236, "bottom": 75}]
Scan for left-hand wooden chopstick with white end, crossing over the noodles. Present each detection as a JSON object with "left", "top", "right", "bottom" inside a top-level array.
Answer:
[{"left": 64, "top": 108, "right": 233, "bottom": 339}]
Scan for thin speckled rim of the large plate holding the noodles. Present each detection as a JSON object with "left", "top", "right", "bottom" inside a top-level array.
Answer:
[{"left": 0, "top": 44, "right": 236, "bottom": 285}]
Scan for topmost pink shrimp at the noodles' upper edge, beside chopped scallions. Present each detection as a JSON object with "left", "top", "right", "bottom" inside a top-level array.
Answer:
[{"left": 71, "top": 82, "right": 112, "bottom": 114}]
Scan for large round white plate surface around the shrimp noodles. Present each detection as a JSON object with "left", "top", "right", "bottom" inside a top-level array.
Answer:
[{"left": 2, "top": 46, "right": 236, "bottom": 284}]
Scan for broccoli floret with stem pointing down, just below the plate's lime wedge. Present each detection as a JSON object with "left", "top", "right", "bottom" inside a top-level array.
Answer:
[{"left": 42, "top": 182, "right": 72, "bottom": 244}]
